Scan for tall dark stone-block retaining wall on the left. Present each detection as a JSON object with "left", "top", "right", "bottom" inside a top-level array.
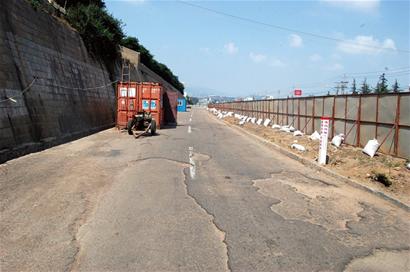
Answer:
[{"left": 0, "top": 0, "right": 116, "bottom": 163}]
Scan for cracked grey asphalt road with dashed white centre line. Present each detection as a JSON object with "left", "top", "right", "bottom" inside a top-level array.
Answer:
[{"left": 0, "top": 109, "right": 410, "bottom": 271}]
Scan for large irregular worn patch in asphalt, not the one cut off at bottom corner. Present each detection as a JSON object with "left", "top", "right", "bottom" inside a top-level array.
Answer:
[{"left": 253, "top": 172, "right": 363, "bottom": 230}]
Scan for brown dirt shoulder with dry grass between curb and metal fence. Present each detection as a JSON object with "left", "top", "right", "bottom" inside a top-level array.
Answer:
[{"left": 219, "top": 117, "right": 410, "bottom": 205}]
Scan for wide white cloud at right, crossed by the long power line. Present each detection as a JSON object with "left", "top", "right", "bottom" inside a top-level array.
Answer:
[{"left": 337, "top": 36, "right": 396, "bottom": 55}]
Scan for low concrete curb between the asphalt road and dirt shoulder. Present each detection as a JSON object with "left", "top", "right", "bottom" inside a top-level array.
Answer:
[{"left": 210, "top": 114, "right": 410, "bottom": 212}]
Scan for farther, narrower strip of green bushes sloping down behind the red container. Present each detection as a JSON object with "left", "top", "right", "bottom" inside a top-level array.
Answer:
[{"left": 121, "top": 37, "right": 184, "bottom": 93}]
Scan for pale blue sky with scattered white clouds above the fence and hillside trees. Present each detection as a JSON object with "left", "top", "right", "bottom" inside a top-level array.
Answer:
[{"left": 105, "top": 0, "right": 410, "bottom": 96}]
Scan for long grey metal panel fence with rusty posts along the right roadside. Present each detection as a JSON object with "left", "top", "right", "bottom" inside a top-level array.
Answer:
[{"left": 215, "top": 92, "right": 410, "bottom": 158}]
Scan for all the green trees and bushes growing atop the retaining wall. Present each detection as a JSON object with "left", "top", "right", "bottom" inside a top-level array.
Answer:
[{"left": 29, "top": 0, "right": 184, "bottom": 93}]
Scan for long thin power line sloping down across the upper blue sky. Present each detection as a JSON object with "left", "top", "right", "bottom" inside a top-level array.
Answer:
[{"left": 176, "top": 0, "right": 410, "bottom": 54}]
